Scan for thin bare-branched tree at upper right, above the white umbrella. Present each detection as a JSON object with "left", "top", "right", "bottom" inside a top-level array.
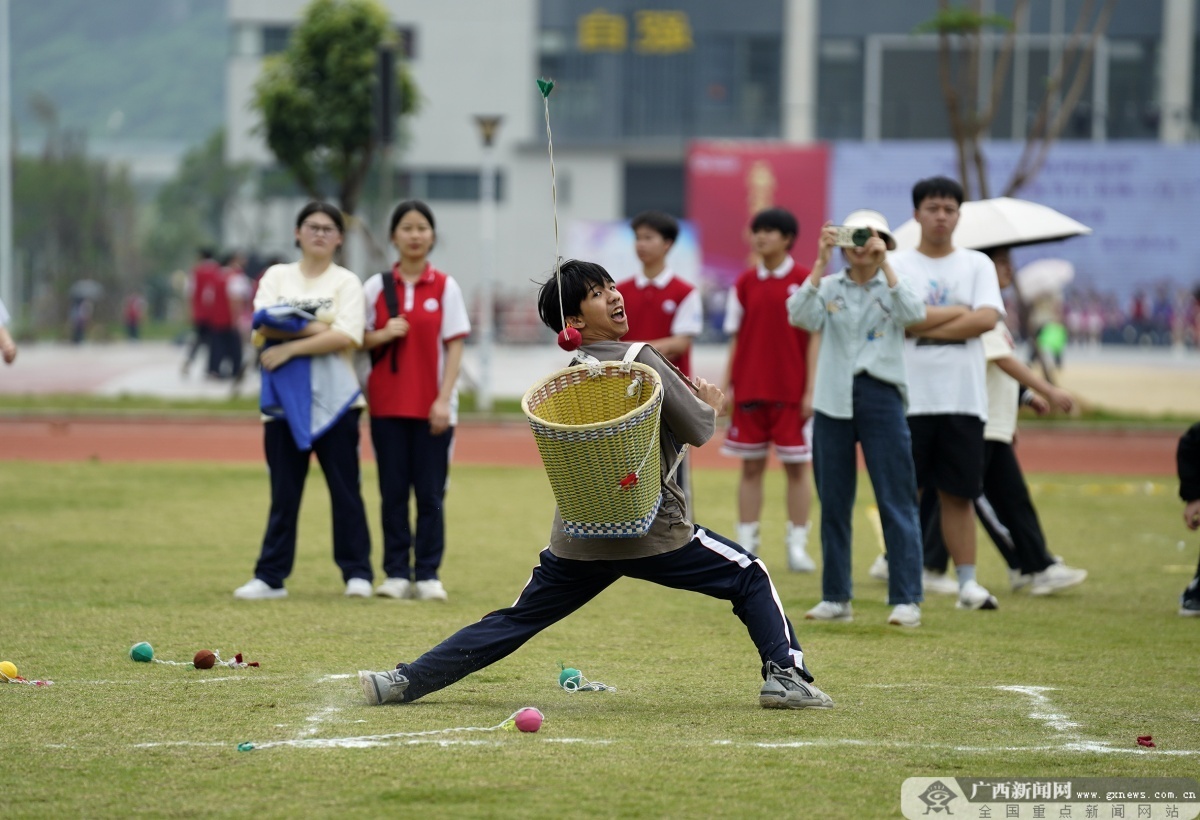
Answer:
[{"left": 918, "top": 0, "right": 1116, "bottom": 199}]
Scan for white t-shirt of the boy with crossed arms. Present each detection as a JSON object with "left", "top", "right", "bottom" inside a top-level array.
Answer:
[{"left": 889, "top": 247, "right": 1004, "bottom": 421}]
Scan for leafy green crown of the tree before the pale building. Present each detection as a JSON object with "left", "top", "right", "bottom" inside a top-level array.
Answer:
[{"left": 253, "top": 0, "right": 416, "bottom": 214}]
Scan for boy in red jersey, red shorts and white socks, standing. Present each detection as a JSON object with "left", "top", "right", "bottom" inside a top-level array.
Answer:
[{"left": 721, "top": 208, "right": 816, "bottom": 573}]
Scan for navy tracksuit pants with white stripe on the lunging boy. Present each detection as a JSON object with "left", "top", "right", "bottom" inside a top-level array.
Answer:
[{"left": 396, "top": 527, "right": 812, "bottom": 701}]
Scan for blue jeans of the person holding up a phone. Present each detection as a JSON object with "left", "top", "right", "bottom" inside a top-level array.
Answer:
[{"left": 812, "top": 373, "right": 923, "bottom": 606}]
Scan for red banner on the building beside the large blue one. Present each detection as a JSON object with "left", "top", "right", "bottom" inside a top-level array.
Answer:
[{"left": 688, "top": 142, "right": 829, "bottom": 287}]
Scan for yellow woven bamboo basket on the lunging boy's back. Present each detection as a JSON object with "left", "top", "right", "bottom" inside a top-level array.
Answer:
[{"left": 521, "top": 361, "right": 662, "bottom": 538}]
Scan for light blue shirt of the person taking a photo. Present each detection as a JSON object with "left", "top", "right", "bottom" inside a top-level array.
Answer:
[{"left": 787, "top": 270, "right": 925, "bottom": 419}]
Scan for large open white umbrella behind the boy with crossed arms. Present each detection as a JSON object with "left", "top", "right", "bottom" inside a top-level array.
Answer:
[{"left": 894, "top": 197, "right": 1092, "bottom": 250}]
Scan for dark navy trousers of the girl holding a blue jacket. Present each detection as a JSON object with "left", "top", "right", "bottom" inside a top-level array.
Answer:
[{"left": 254, "top": 409, "right": 372, "bottom": 588}]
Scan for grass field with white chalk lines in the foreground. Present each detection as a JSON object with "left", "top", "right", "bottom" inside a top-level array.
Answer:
[{"left": 0, "top": 462, "right": 1200, "bottom": 818}]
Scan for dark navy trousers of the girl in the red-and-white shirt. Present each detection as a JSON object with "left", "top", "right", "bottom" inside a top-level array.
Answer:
[{"left": 371, "top": 417, "right": 454, "bottom": 581}]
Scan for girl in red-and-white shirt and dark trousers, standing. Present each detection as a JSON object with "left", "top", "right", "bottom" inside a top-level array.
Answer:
[{"left": 362, "top": 199, "right": 470, "bottom": 600}]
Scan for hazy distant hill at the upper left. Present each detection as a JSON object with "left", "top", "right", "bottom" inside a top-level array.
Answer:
[{"left": 8, "top": 0, "right": 229, "bottom": 144}]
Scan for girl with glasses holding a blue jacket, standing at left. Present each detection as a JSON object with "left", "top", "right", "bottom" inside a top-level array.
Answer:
[{"left": 233, "top": 202, "right": 372, "bottom": 600}]
